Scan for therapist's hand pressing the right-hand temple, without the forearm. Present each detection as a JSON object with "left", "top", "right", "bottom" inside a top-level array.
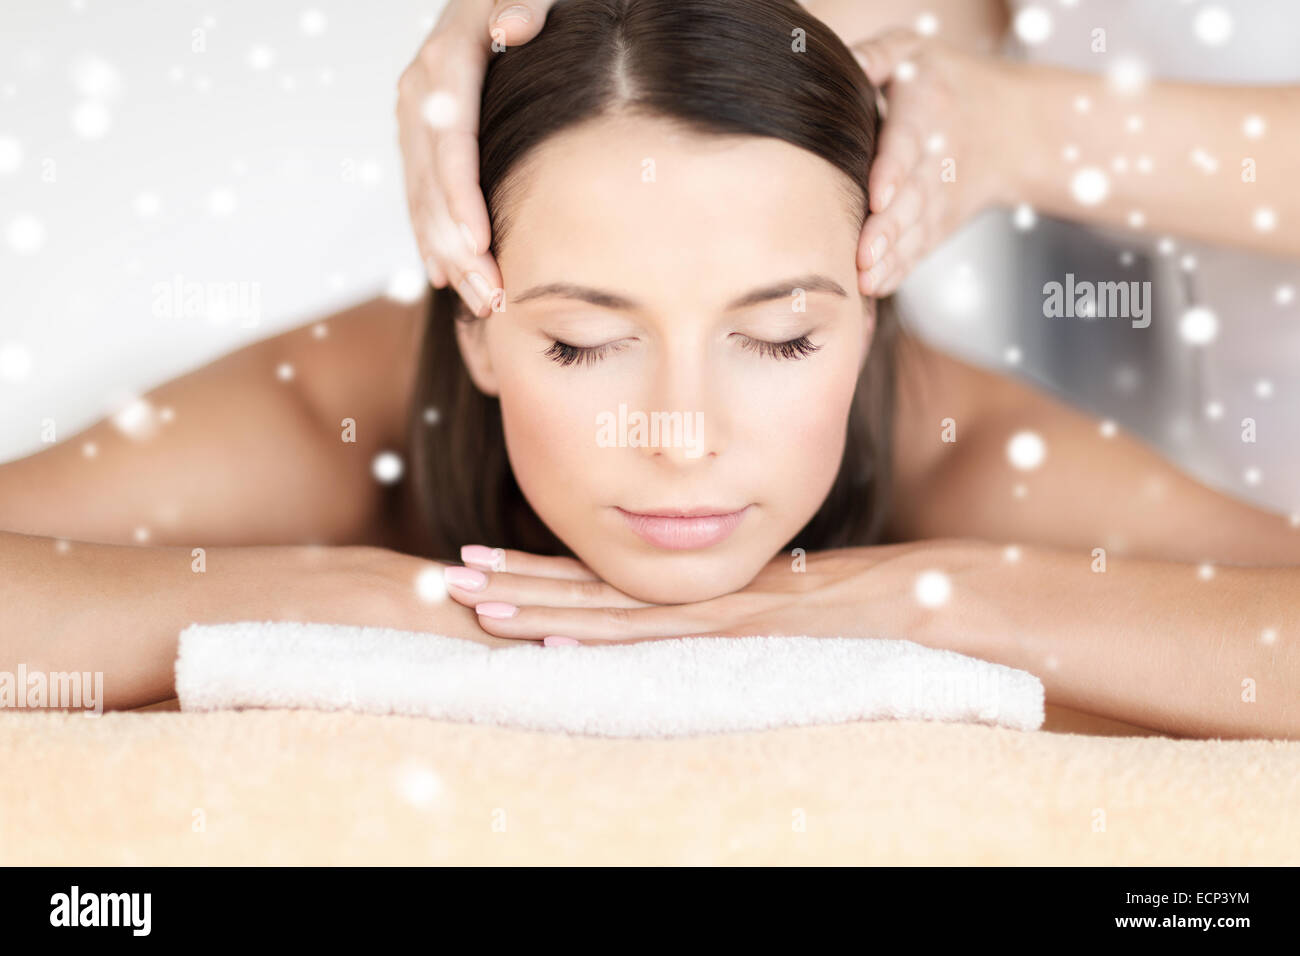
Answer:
[{"left": 853, "top": 30, "right": 1019, "bottom": 295}]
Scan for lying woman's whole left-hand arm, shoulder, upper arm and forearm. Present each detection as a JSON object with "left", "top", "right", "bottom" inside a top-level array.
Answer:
[{"left": 0, "top": 300, "right": 467, "bottom": 708}]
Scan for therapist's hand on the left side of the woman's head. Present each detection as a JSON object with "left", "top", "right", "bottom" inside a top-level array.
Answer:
[{"left": 398, "top": 0, "right": 554, "bottom": 316}]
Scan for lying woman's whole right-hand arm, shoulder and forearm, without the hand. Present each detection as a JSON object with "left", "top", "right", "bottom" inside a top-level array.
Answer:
[{"left": 871, "top": 342, "right": 1300, "bottom": 739}]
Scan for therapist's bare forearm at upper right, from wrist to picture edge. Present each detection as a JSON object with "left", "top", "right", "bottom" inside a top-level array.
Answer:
[{"left": 995, "top": 64, "right": 1300, "bottom": 255}]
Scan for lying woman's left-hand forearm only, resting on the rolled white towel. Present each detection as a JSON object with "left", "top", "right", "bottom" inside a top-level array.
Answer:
[{"left": 0, "top": 532, "right": 498, "bottom": 709}]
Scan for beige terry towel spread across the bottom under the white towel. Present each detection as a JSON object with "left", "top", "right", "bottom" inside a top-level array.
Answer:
[{"left": 0, "top": 710, "right": 1300, "bottom": 865}]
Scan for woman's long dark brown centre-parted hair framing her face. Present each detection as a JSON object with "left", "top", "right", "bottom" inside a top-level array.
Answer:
[{"left": 403, "top": 0, "right": 901, "bottom": 561}]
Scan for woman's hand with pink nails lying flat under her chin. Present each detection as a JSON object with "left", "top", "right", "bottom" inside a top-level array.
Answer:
[{"left": 447, "top": 542, "right": 920, "bottom": 644}]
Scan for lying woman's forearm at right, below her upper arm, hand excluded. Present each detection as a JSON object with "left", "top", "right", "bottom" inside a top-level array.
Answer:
[{"left": 909, "top": 540, "right": 1300, "bottom": 739}]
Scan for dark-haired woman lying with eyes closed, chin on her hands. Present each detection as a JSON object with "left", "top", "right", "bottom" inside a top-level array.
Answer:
[{"left": 0, "top": 0, "right": 1300, "bottom": 737}]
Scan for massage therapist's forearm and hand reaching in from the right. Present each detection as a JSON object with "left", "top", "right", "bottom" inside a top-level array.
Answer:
[{"left": 855, "top": 31, "right": 1300, "bottom": 295}]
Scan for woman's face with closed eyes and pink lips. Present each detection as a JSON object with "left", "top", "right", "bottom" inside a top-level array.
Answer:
[{"left": 460, "top": 117, "right": 874, "bottom": 604}]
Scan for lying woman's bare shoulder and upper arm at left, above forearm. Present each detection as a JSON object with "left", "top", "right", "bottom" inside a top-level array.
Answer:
[{"left": 0, "top": 299, "right": 423, "bottom": 546}]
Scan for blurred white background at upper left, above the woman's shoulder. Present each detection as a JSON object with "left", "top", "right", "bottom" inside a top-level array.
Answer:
[{"left": 0, "top": 0, "right": 442, "bottom": 460}]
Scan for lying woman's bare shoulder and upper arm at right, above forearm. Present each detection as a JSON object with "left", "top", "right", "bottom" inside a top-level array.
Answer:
[{"left": 888, "top": 327, "right": 1300, "bottom": 564}]
